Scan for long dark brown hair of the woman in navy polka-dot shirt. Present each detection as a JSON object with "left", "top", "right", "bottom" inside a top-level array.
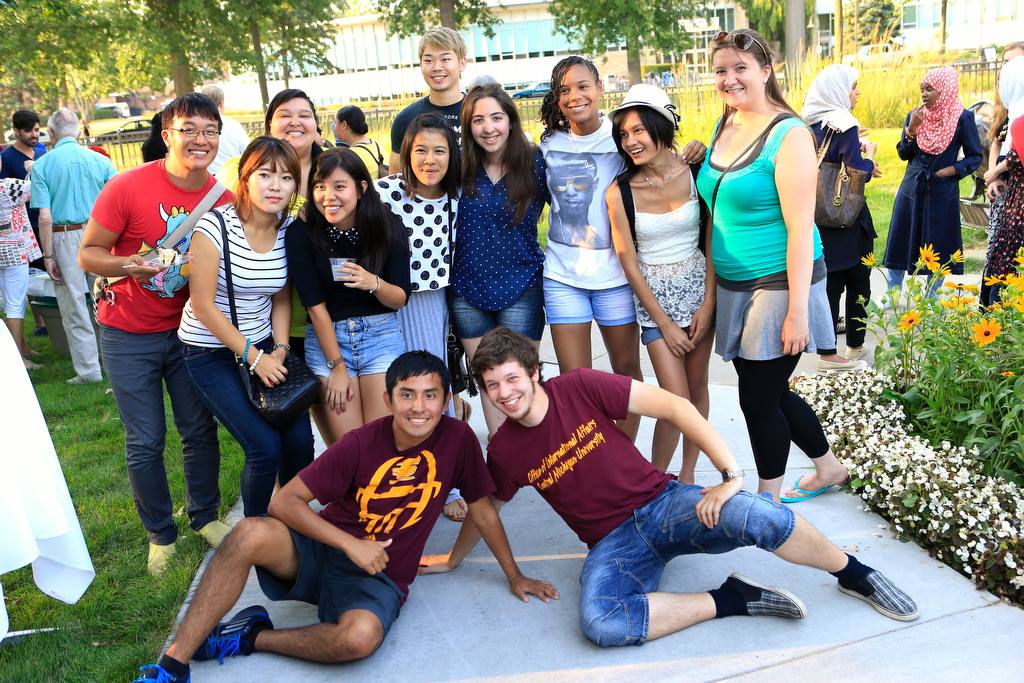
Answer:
[{"left": 461, "top": 83, "right": 537, "bottom": 225}]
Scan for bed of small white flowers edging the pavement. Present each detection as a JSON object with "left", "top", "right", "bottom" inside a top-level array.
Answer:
[{"left": 793, "top": 370, "right": 1024, "bottom": 603}]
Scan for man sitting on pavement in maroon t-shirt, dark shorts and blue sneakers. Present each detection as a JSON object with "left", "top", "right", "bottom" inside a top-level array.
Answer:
[{"left": 138, "top": 351, "right": 558, "bottom": 683}]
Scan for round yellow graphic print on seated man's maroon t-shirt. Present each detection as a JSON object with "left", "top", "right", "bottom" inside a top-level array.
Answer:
[{"left": 355, "top": 451, "right": 441, "bottom": 535}]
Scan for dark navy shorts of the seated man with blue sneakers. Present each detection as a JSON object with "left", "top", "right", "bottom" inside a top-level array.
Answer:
[{"left": 256, "top": 529, "right": 402, "bottom": 637}]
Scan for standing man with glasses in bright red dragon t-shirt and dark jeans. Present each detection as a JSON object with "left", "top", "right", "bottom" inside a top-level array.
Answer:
[{"left": 78, "top": 93, "right": 234, "bottom": 574}]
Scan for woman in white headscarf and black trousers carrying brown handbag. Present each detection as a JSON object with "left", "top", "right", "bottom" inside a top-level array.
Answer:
[{"left": 801, "top": 65, "right": 882, "bottom": 370}]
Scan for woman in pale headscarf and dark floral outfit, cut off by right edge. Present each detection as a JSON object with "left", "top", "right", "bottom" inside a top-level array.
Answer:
[{"left": 981, "top": 54, "right": 1024, "bottom": 305}]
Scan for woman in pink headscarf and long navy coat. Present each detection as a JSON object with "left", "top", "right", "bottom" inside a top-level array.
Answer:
[{"left": 883, "top": 67, "right": 981, "bottom": 296}]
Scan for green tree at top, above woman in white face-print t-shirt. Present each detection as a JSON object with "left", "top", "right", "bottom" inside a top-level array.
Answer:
[{"left": 550, "top": 0, "right": 698, "bottom": 83}]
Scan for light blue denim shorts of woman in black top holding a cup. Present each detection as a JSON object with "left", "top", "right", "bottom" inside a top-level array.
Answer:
[{"left": 305, "top": 313, "right": 406, "bottom": 377}]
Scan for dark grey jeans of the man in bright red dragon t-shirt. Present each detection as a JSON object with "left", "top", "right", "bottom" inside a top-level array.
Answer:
[{"left": 99, "top": 326, "right": 220, "bottom": 546}]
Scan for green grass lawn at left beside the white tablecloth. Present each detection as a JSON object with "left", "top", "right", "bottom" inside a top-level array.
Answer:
[{"left": 0, "top": 313, "right": 243, "bottom": 683}]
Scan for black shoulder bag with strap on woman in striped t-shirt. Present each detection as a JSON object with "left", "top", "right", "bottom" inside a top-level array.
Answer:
[{"left": 213, "top": 211, "right": 321, "bottom": 429}]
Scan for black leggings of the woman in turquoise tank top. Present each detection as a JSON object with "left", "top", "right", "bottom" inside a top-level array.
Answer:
[{"left": 732, "top": 355, "right": 828, "bottom": 479}]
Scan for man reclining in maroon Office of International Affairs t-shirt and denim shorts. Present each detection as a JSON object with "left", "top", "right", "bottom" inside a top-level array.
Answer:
[{"left": 427, "top": 328, "right": 918, "bottom": 646}]
